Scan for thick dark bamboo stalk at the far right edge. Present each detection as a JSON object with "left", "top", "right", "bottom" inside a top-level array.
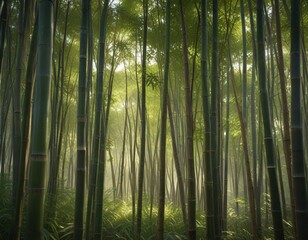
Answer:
[{"left": 290, "top": 0, "right": 308, "bottom": 240}]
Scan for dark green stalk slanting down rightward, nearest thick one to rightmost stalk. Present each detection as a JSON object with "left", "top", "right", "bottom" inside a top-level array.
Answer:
[{"left": 257, "top": 0, "right": 284, "bottom": 240}]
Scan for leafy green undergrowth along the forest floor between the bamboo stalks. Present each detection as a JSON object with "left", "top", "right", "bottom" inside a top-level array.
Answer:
[{"left": 0, "top": 178, "right": 293, "bottom": 240}]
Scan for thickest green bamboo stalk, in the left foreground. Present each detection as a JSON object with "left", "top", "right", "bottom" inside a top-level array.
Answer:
[{"left": 26, "top": 0, "right": 54, "bottom": 240}]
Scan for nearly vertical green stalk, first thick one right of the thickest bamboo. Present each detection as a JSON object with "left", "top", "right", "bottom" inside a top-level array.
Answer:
[{"left": 74, "top": 0, "right": 91, "bottom": 240}]
